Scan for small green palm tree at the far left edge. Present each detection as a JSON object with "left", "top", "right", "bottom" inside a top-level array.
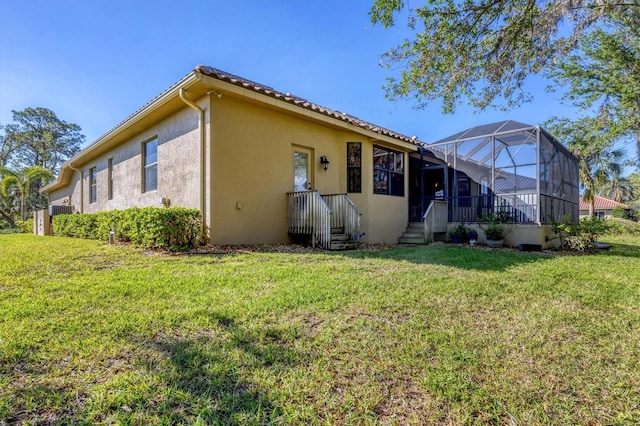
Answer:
[{"left": 0, "top": 166, "right": 53, "bottom": 220}]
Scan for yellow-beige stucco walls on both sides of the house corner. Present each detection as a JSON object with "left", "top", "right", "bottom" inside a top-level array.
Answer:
[{"left": 50, "top": 94, "right": 408, "bottom": 244}]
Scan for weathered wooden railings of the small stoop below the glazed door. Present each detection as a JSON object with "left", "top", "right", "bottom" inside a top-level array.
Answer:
[{"left": 287, "top": 191, "right": 360, "bottom": 249}]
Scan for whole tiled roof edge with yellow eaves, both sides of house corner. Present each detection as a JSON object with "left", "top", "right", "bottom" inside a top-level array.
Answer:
[{"left": 40, "top": 65, "right": 424, "bottom": 193}]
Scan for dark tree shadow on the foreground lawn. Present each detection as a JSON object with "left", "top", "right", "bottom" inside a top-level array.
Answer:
[{"left": 142, "top": 316, "right": 301, "bottom": 425}]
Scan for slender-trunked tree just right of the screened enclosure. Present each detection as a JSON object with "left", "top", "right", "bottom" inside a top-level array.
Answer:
[{"left": 546, "top": 117, "right": 625, "bottom": 217}]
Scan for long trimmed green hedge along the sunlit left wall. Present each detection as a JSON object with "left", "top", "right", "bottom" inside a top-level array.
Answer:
[{"left": 53, "top": 207, "right": 202, "bottom": 251}]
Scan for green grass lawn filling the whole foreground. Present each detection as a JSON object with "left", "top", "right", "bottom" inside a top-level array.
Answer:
[{"left": 0, "top": 234, "right": 640, "bottom": 425}]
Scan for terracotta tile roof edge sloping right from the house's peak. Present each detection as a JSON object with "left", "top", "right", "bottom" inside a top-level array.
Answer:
[{"left": 194, "top": 65, "right": 422, "bottom": 145}]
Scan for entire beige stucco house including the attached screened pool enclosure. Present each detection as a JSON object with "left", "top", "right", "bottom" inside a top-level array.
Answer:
[{"left": 42, "top": 66, "right": 578, "bottom": 248}]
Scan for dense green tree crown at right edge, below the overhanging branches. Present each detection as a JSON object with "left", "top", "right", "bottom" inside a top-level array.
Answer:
[{"left": 551, "top": 12, "right": 640, "bottom": 165}]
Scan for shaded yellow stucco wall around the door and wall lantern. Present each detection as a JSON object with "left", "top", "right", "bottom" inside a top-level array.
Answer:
[{"left": 210, "top": 96, "right": 408, "bottom": 244}]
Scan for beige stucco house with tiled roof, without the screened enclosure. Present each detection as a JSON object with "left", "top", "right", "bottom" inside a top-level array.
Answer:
[{"left": 42, "top": 66, "right": 418, "bottom": 248}]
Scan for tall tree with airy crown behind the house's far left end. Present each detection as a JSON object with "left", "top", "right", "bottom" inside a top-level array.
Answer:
[{"left": 0, "top": 107, "right": 84, "bottom": 173}]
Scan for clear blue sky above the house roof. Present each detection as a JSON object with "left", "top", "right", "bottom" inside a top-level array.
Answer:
[{"left": 0, "top": 0, "right": 575, "bottom": 147}]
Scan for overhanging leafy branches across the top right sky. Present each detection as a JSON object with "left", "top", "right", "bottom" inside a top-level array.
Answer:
[{"left": 370, "top": 0, "right": 640, "bottom": 112}]
